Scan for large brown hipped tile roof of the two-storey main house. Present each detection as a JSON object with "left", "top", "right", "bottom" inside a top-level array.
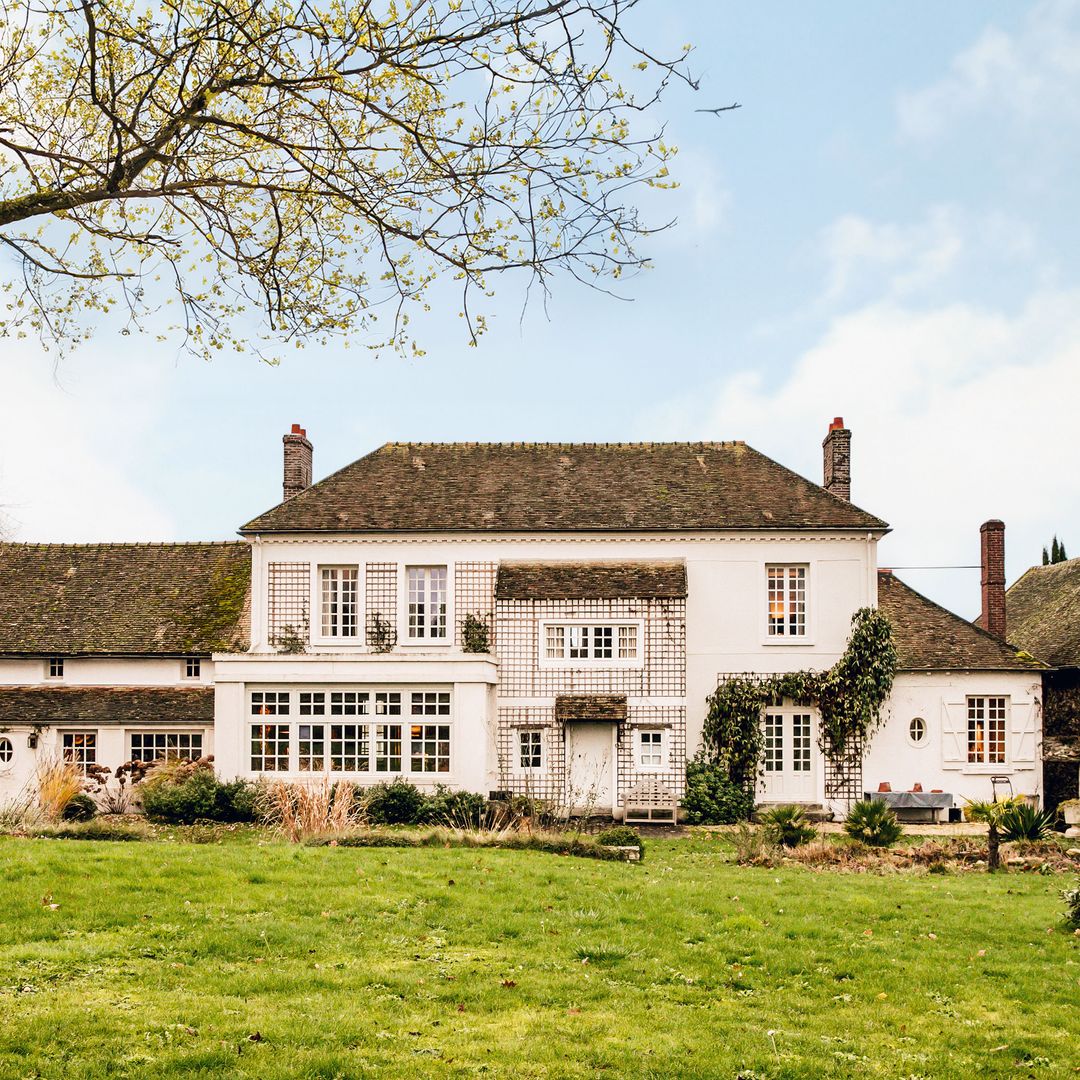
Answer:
[{"left": 241, "top": 442, "right": 887, "bottom": 532}]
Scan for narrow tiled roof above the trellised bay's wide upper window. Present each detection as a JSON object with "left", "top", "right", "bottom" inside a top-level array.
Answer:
[{"left": 495, "top": 562, "right": 686, "bottom": 600}]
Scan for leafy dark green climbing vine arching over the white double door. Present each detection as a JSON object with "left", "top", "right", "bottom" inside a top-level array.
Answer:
[{"left": 702, "top": 608, "right": 896, "bottom": 788}]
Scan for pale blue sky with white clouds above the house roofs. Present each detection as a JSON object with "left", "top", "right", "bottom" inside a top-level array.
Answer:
[{"left": 0, "top": 0, "right": 1080, "bottom": 616}]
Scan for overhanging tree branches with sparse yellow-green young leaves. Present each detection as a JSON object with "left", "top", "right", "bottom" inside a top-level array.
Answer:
[{"left": 0, "top": 0, "right": 691, "bottom": 355}]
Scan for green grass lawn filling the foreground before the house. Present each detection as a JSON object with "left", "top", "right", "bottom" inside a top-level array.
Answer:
[{"left": 0, "top": 837, "right": 1080, "bottom": 1080}]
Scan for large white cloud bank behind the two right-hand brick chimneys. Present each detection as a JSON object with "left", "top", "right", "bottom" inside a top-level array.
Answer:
[{"left": 643, "top": 291, "right": 1080, "bottom": 616}]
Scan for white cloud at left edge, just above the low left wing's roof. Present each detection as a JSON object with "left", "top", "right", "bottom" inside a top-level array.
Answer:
[{"left": 0, "top": 341, "right": 174, "bottom": 542}]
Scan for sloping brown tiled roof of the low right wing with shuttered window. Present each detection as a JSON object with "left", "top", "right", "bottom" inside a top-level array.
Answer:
[{"left": 878, "top": 570, "right": 1043, "bottom": 671}]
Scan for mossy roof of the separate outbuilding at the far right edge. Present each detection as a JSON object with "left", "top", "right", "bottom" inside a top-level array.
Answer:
[{"left": 1005, "top": 558, "right": 1080, "bottom": 667}]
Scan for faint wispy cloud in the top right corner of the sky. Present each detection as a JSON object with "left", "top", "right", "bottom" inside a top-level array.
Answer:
[{"left": 896, "top": 0, "right": 1080, "bottom": 139}]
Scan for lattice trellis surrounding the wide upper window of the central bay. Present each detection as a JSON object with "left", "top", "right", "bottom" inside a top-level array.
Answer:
[{"left": 495, "top": 599, "right": 686, "bottom": 698}]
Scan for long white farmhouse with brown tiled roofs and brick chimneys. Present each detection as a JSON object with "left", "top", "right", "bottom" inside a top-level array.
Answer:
[{"left": 0, "top": 420, "right": 1040, "bottom": 816}]
